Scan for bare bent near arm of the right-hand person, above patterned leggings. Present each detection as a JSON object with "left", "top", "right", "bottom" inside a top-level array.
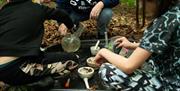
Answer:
[{"left": 95, "top": 47, "right": 151, "bottom": 74}]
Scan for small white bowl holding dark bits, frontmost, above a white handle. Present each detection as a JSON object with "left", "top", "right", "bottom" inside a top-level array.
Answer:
[{"left": 78, "top": 67, "right": 94, "bottom": 79}]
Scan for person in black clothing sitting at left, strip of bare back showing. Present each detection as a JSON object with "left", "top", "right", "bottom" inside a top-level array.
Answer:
[{"left": 0, "top": 0, "right": 78, "bottom": 85}]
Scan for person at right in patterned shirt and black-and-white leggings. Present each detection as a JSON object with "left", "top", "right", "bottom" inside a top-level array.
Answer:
[{"left": 95, "top": 0, "right": 180, "bottom": 91}]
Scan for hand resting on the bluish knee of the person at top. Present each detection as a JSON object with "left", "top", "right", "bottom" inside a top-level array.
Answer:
[{"left": 90, "top": 1, "right": 104, "bottom": 19}]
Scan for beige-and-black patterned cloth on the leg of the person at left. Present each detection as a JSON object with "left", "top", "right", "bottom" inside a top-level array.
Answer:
[{"left": 20, "top": 60, "right": 78, "bottom": 76}]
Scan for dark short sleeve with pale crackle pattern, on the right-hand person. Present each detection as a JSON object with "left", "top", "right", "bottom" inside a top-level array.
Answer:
[{"left": 140, "top": 7, "right": 179, "bottom": 54}]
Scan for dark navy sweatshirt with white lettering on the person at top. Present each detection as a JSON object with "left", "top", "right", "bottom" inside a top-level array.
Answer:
[{"left": 56, "top": 0, "right": 119, "bottom": 15}]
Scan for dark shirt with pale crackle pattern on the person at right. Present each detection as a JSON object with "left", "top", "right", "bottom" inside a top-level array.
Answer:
[{"left": 140, "top": 4, "right": 180, "bottom": 88}]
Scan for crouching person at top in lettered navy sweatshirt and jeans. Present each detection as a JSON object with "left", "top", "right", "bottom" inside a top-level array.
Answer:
[{"left": 57, "top": 0, "right": 119, "bottom": 38}]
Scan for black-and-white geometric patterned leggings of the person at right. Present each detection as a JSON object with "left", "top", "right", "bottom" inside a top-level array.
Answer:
[{"left": 99, "top": 63, "right": 162, "bottom": 91}]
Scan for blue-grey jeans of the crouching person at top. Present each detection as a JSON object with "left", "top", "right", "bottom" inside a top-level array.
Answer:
[{"left": 59, "top": 6, "right": 112, "bottom": 35}]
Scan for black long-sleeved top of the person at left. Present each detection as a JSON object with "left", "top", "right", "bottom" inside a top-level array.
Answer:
[{"left": 0, "top": 0, "right": 73, "bottom": 57}]
